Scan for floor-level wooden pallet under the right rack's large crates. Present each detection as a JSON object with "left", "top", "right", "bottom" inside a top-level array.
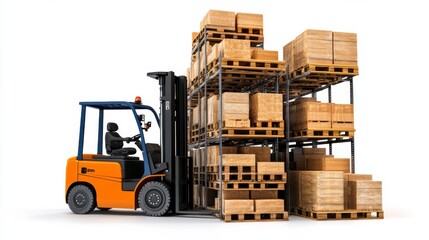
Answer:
[{"left": 290, "top": 208, "right": 384, "bottom": 220}]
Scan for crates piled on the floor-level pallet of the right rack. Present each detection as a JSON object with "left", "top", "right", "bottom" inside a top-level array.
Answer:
[{"left": 288, "top": 148, "right": 383, "bottom": 220}]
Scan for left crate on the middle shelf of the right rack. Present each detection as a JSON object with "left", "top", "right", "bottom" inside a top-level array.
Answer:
[{"left": 290, "top": 102, "right": 332, "bottom": 130}]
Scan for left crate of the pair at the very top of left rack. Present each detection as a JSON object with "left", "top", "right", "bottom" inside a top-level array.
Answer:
[{"left": 200, "top": 10, "right": 235, "bottom": 31}]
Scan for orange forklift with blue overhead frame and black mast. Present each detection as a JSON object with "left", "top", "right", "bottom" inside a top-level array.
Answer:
[{"left": 65, "top": 72, "right": 210, "bottom": 216}]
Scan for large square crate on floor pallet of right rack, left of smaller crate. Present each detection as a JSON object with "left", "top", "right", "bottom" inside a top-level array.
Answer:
[{"left": 299, "top": 171, "right": 344, "bottom": 211}]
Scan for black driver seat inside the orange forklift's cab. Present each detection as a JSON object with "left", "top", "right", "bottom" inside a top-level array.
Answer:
[{"left": 105, "top": 122, "right": 136, "bottom": 157}]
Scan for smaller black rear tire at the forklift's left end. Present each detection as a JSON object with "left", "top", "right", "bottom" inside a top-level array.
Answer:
[{"left": 67, "top": 185, "right": 95, "bottom": 214}]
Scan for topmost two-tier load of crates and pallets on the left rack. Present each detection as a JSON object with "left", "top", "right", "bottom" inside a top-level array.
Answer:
[{"left": 187, "top": 10, "right": 285, "bottom": 93}]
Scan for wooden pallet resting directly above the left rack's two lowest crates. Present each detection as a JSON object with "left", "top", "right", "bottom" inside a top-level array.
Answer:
[{"left": 209, "top": 181, "right": 285, "bottom": 190}]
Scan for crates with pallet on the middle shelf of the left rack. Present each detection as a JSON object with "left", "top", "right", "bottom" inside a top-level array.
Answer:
[{"left": 190, "top": 92, "right": 284, "bottom": 142}]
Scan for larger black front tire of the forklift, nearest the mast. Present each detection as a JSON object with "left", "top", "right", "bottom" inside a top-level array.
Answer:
[{"left": 138, "top": 181, "right": 171, "bottom": 217}]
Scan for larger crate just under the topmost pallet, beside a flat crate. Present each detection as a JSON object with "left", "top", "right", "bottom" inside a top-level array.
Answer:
[{"left": 217, "top": 39, "right": 252, "bottom": 59}]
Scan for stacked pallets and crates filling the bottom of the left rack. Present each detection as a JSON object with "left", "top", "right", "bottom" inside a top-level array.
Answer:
[{"left": 193, "top": 145, "right": 288, "bottom": 222}]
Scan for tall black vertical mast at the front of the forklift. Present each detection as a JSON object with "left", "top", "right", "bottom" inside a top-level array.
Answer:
[{"left": 147, "top": 72, "right": 193, "bottom": 214}]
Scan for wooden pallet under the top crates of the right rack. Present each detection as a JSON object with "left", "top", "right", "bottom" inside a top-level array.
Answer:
[{"left": 290, "top": 64, "right": 359, "bottom": 78}]
